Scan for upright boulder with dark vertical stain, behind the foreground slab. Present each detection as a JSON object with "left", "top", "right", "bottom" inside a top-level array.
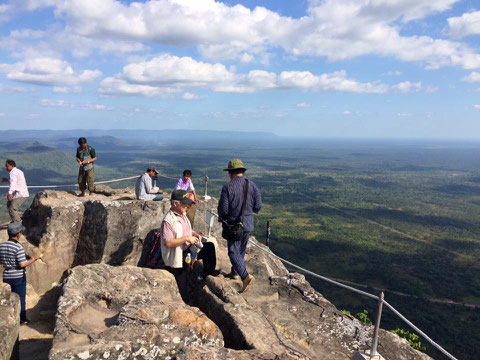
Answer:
[{"left": 22, "top": 189, "right": 169, "bottom": 295}]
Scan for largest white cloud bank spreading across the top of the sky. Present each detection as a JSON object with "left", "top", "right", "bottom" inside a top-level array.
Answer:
[{"left": 35, "top": 0, "right": 474, "bottom": 69}]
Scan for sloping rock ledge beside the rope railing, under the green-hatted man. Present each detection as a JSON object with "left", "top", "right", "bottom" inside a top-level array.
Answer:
[{"left": 196, "top": 238, "right": 430, "bottom": 360}]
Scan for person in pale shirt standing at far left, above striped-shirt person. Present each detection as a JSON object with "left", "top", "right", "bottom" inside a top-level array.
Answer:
[{"left": 2, "top": 160, "right": 30, "bottom": 223}]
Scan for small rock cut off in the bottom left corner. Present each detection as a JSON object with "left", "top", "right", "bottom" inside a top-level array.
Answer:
[{"left": 0, "top": 282, "right": 20, "bottom": 360}]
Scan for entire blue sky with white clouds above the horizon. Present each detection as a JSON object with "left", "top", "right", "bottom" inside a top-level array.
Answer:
[{"left": 0, "top": 0, "right": 480, "bottom": 139}]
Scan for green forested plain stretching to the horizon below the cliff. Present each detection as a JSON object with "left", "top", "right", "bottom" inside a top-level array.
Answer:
[{"left": 0, "top": 137, "right": 480, "bottom": 359}]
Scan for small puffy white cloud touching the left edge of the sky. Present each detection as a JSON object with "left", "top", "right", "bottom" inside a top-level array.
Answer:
[{"left": 0, "top": 58, "right": 101, "bottom": 86}]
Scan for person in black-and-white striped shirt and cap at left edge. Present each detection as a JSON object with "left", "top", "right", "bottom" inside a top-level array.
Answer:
[{"left": 0, "top": 222, "right": 37, "bottom": 324}]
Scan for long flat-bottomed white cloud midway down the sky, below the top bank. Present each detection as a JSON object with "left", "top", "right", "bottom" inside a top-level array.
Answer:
[{"left": 99, "top": 54, "right": 394, "bottom": 96}]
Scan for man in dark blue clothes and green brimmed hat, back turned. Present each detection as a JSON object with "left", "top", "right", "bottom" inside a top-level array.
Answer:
[{"left": 218, "top": 159, "right": 262, "bottom": 292}]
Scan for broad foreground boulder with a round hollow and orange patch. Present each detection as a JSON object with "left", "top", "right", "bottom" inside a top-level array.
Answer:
[{"left": 49, "top": 264, "right": 223, "bottom": 360}]
